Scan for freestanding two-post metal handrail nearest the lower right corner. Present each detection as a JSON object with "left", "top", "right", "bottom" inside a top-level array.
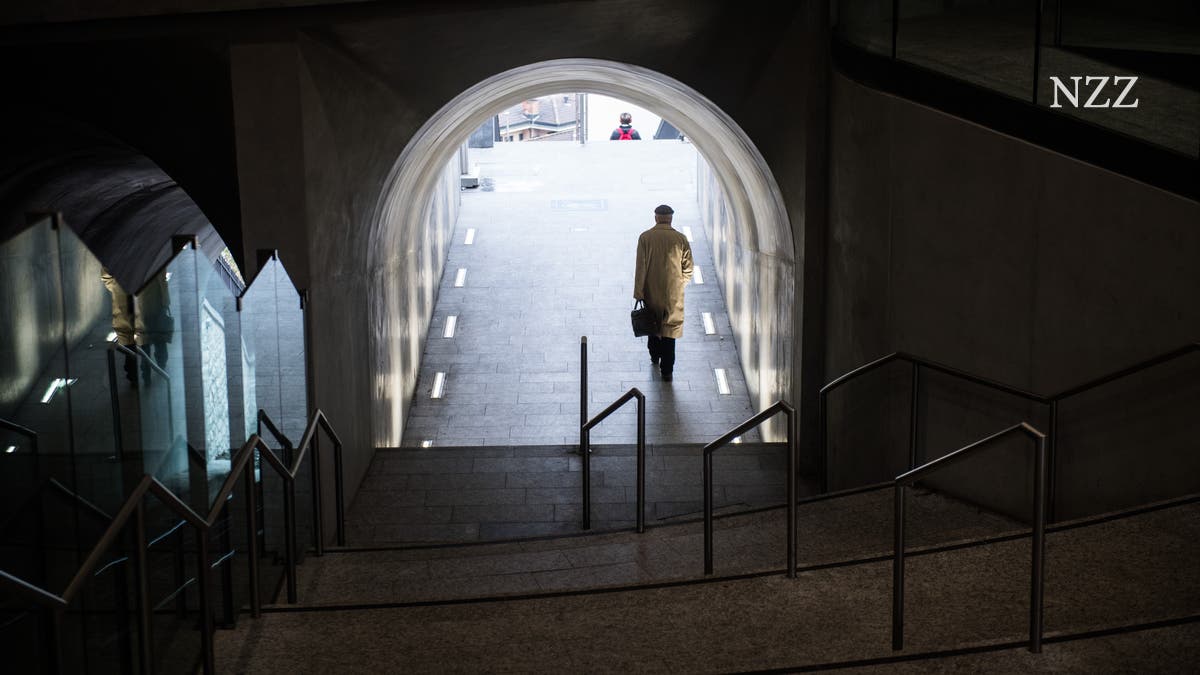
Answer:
[{"left": 892, "top": 422, "right": 1049, "bottom": 653}]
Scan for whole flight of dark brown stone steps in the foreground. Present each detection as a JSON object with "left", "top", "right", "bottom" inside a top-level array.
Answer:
[{"left": 217, "top": 454, "right": 1200, "bottom": 673}]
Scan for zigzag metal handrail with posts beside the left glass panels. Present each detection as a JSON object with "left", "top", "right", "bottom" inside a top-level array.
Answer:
[{"left": 0, "top": 410, "right": 346, "bottom": 674}]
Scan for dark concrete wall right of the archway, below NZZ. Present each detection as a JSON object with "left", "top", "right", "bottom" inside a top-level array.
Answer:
[{"left": 826, "top": 74, "right": 1200, "bottom": 518}]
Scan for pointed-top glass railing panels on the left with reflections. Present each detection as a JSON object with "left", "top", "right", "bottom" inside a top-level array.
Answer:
[{"left": 0, "top": 215, "right": 312, "bottom": 673}]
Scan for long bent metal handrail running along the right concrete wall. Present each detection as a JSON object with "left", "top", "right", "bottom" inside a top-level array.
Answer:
[{"left": 817, "top": 342, "right": 1200, "bottom": 510}]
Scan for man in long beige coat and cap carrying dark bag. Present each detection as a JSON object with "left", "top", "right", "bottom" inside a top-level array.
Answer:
[{"left": 634, "top": 204, "right": 691, "bottom": 380}]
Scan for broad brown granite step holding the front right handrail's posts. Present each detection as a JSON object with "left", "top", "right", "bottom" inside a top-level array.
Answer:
[{"left": 217, "top": 503, "right": 1200, "bottom": 673}]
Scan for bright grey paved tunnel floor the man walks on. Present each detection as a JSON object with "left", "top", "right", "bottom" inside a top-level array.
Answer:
[{"left": 402, "top": 141, "right": 758, "bottom": 447}]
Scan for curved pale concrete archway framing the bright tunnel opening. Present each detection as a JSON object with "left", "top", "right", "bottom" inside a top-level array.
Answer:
[{"left": 368, "top": 59, "right": 796, "bottom": 447}]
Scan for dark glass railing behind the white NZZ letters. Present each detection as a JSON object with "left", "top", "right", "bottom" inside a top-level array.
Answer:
[{"left": 835, "top": 0, "right": 1200, "bottom": 159}]
